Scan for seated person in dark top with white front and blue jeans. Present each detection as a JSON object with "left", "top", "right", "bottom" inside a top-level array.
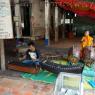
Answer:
[{"left": 22, "top": 42, "right": 40, "bottom": 66}]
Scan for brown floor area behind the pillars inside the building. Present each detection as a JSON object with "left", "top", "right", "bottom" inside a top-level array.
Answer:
[{"left": 36, "top": 37, "right": 81, "bottom": 48}]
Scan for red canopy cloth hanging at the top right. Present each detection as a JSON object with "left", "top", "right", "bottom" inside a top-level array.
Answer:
[{"left": 55, "top": 0, "right": 95, "bottom": 18}]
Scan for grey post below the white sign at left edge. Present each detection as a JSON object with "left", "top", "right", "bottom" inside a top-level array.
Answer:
[{"left": 0, "top": 40, "right": 6, "bottom": 71}]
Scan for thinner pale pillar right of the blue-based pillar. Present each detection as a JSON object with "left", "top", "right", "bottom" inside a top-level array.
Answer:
[{"left": 54, "top": 6, "right": 59, "bottom": 42}]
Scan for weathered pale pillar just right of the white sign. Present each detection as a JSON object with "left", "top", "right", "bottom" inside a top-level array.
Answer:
[{"left": 14, "top": 0, "right": 22, "bottom": 38}]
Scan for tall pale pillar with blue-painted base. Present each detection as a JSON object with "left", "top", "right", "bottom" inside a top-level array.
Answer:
[{"left": 45, "top": 0, "right": 50, "bottom": 46}]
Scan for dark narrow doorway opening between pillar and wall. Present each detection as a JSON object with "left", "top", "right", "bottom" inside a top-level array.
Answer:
[{"left": 21, "top": 2, "right": 32, "bottom": 37}]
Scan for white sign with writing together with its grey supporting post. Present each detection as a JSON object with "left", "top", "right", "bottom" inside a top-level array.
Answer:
[{"left": 0, "top": 0, "right": 13, "bottom": 71}]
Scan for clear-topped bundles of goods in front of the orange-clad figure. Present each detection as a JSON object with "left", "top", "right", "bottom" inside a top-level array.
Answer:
[{"left": 68, "top": 47, "right": 95, "bottom": 67}]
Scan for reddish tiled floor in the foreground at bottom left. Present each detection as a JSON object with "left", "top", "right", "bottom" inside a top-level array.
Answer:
[{"left": 0, "top": 76, "right": 54, "bottom": 95}]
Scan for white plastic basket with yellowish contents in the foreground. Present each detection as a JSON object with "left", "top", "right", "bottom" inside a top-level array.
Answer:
[{"left": 54, "top": 72, "right": 83, "bottom": 95}]
